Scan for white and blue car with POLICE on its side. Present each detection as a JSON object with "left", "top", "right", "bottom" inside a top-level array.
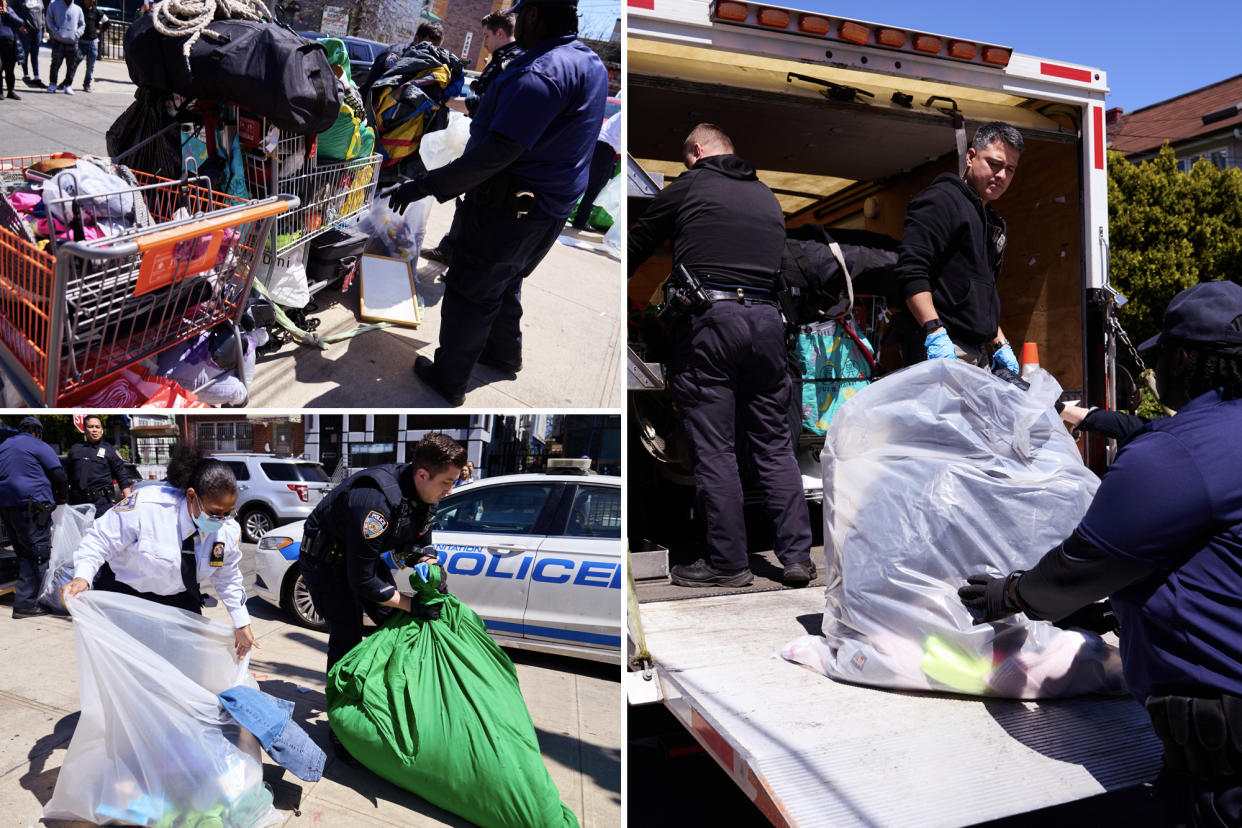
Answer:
[{"left": 255, "top": 474, "right": 623, "bottom": 662}]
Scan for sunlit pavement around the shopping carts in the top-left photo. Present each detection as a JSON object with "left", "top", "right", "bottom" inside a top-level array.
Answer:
[{"left": 0, "top": 52, "right": 625, "bottom": 408}]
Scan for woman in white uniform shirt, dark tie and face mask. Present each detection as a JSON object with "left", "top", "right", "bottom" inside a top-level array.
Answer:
[{"left": 63, "top": 451, "right": 258, "bottom": 658}]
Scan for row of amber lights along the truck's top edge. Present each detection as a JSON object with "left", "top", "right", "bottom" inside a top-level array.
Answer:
[{"left": 712, "top": 0, "right": 1013, "bottom": 68}]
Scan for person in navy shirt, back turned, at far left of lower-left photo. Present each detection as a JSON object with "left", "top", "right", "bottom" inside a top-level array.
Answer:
[{"left": 0, "top": 417, "right": 68, "bottom": 618}]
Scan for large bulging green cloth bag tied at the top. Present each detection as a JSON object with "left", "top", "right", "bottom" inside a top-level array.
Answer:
[{"left": 328, "top": 564, "right": 578, "bottom": 828}]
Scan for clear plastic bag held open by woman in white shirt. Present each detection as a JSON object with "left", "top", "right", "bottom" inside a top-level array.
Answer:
[{"left": 43, "top": 590, "right": 279, "bottom": 828}]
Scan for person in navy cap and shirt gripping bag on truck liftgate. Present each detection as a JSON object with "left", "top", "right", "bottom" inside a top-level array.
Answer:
[{"left": 959, "top": 282, "right": 1242, "bottom": 826}]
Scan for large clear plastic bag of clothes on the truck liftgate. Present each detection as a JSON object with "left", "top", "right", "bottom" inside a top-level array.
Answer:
[{"left": 781, "top": 360, "right": 1124, "bottom": 699}]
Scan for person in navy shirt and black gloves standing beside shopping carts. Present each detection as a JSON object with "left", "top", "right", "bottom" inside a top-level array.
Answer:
[{"left": 380, "top": 0, "right": 609, "bottom": 406}]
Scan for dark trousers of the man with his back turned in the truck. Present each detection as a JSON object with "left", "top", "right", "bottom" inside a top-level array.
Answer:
[{"left": 668, "top": 300, "right": 811, "bottom": 571}]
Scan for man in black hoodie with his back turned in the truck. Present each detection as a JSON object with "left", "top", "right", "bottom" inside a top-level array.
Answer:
[{"left": 627, "top": 124, "right": 815, "bottom": 586}]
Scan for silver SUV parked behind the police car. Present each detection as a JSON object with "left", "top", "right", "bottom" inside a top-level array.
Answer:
[{"left": 211, "top": 452, "right": 329, "bottom": 544}]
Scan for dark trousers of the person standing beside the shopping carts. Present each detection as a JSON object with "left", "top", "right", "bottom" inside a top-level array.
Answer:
[{"left": 433, "top": 194, "right": 565, "bottom": 394}]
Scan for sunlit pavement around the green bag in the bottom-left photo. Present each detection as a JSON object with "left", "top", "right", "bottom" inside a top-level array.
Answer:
[{"left": 0, "top": 545, "right": 621, "bottom": 828}]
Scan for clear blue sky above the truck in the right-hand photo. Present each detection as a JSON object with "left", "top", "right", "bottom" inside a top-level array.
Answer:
[{"left": 774, "top": 0, "right": 1242, "bottom": 112}]
